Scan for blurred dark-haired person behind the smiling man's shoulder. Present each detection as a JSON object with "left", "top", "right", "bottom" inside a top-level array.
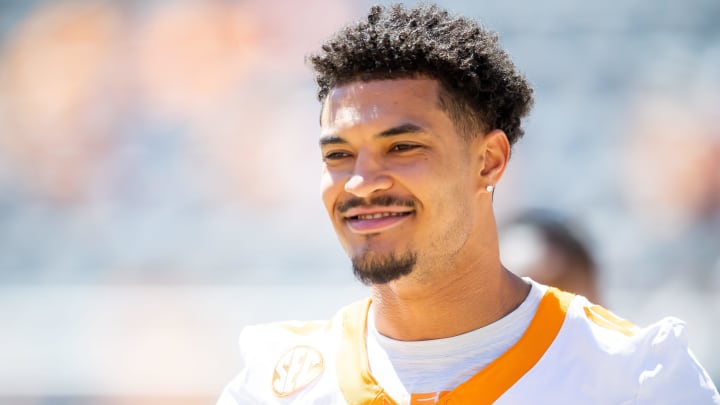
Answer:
[{"left": 500, "top": 210, "right": 602, "bottom": 304}]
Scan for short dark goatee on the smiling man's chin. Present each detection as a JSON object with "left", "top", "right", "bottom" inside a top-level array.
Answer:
[{"left": 352, "top": 252, "right": 417, "bottom": 286}]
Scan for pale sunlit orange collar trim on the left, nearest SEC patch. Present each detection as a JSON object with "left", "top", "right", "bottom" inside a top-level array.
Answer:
[{"left": 337, "top": 298, "right": 397, "bottom": 405}]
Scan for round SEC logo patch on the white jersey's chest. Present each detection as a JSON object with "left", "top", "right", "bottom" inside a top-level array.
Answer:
[{"left": 272, "top": 346, "right": 325, "bottom": 397}]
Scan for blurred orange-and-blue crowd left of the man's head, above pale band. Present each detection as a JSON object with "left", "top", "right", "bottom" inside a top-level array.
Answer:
[{"left": 0, "top": 0, "right": 360, "bottom": 283}]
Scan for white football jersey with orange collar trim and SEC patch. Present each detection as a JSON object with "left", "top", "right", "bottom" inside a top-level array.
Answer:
[{"left": 218, "top": 288, "right": 720, "bottom": 405}]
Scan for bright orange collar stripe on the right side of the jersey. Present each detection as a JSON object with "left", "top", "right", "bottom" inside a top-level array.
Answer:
[{"left": 438, "top": 287, "right": 575, "bottom": 404}]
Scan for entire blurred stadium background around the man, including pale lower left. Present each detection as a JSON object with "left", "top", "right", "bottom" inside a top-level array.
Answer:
[{"left": 0, "top": 0, "right": 720, "bottom": 405}]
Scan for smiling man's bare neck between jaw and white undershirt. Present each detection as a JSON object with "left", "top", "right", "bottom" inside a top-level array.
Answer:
[{"left": 372, "top": 261, "right": 530, "bottom": 341}]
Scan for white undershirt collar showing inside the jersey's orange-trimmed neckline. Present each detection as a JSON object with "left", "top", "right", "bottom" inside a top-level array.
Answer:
[{"left": 367, "top": 278, "right": 546, "bottom": 403}]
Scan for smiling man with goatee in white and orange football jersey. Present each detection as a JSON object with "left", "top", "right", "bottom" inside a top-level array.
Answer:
[{"left": 219, "top": 6, "right": 720, "bottom": 405}]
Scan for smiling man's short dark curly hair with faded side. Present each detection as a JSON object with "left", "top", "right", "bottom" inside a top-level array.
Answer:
[{"left": 308, "top": 4, "right": 533, "bottom": 144}]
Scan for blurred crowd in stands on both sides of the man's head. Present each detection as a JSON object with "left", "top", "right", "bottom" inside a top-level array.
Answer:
[{"left": 0, "top": 0, "right": 720, "bottom": 400}]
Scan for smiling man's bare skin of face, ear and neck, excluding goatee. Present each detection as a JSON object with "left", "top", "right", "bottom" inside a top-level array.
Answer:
[{"left": 320, "top": 78, "right": 530, "bottom": 340}]
